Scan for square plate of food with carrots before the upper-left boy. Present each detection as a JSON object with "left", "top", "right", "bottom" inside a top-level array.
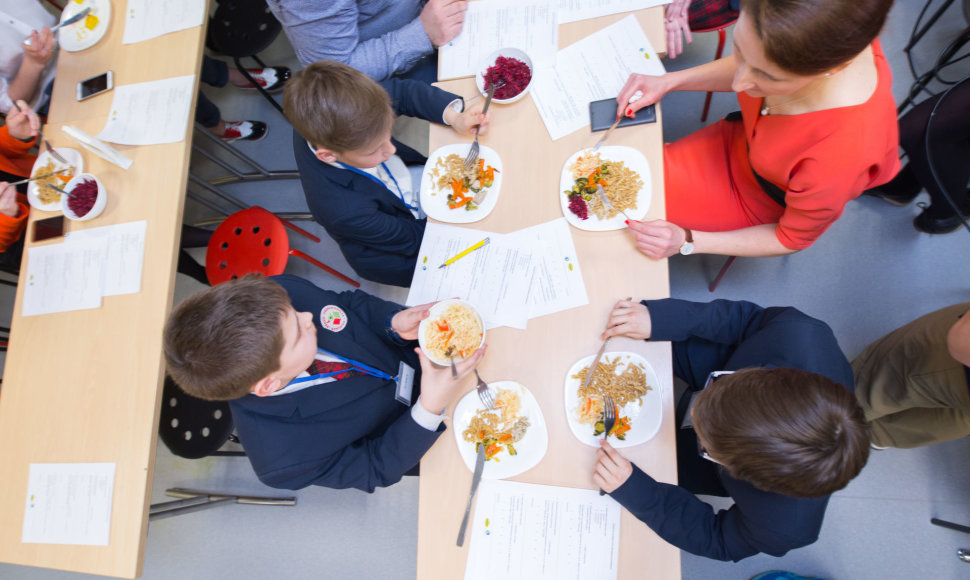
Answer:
[{"left": 420, "top": 143, "right": 502, "bottom": 224}]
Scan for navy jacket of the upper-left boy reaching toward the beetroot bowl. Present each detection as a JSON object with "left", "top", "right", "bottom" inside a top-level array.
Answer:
[{"left": 293, "top": 78, "right": 459, "bottom": 286}]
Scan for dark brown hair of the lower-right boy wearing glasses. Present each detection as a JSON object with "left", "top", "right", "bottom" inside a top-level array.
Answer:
[{"left": 693, "top": 368, "right": 869, "bottom": 497}]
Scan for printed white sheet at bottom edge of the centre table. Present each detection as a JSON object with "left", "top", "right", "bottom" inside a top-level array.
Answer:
[{"left": 465, "top": 479, "right": 620, "bottom": 580}]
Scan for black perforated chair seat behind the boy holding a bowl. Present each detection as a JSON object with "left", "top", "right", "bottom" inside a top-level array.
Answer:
[{"left": 158, "top": 375, "right": 246, "bottom": 459}]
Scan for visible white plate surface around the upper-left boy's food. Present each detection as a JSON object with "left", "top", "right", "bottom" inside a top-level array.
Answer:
[{"left": 420, "top": 143, "right": 502, "bottom": 224}]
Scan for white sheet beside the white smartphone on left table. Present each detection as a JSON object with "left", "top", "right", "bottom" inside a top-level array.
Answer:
[{"left": 98, "top": 75, "right": 195, "bottom": 145}]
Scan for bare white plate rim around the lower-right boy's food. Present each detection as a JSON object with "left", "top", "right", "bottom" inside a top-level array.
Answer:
[{"left": 563, "top": 351, "right": 663, "bottom": 448}]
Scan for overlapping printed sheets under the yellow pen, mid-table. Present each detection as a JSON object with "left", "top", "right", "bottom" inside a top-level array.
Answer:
[{"left": 407, "top": 218, "right": 589, "bottom": 329}]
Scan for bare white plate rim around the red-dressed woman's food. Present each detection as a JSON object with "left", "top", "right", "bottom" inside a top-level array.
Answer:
[{"left": 559, "top": 145, "right": 652, "bottom": 232}]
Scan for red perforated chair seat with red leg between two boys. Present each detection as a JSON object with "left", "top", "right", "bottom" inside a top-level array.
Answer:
[{"left": 205, "top": 205, "right": 360, "bottom": 288}]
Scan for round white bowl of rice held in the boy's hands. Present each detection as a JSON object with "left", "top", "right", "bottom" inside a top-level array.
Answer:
[{"left": 418, "top": 299, "right": 485, "bottom": 366}]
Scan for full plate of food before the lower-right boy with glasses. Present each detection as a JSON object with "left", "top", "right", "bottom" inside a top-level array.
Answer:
[{"left": 564, "top": 352, "right": 663, "bottom": 447}]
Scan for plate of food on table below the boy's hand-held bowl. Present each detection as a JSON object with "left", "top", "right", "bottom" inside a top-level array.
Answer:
[{"left": 452, "top": 381, "right": 549, "bottom": 479}]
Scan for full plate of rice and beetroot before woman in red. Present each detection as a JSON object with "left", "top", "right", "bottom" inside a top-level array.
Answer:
[{"left": 559, "top": 145, "right": 651, "bottom": 232}]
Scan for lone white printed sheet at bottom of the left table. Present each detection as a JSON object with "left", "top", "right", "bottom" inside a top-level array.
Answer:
[{"left": 21, "top": 463, "right": 115, "bottom": 546}]
